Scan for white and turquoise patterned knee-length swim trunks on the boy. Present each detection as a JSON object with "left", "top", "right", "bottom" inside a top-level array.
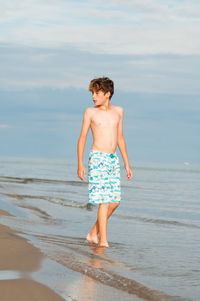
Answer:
[{"left": 88, "top": 150, "right": 121, "bottom": 204}]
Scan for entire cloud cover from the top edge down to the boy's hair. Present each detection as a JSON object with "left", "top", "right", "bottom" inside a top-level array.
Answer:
[{"left": 0, "top": 0, "right": 200, "bottom": 94}]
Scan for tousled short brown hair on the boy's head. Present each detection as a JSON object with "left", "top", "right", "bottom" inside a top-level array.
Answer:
[{"left": 89, "top": 77, "right": 114, "bottom": 99}]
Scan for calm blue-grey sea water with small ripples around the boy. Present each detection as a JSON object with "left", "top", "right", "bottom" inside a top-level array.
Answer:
[{"left": 0, "top": 157, "right": 200, "bottom": 301}]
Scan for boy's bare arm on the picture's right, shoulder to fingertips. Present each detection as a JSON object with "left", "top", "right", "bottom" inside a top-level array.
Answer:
[{"left": 117, "top": 107, "right": 133, "bottom": 180}]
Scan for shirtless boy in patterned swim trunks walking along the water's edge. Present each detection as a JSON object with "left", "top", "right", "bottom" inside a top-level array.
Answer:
[{"left": 77, "top": 77, "right": 133, "bottom": 247}]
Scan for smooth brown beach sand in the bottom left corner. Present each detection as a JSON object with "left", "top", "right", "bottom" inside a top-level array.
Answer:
[{"left": 0, "top": 210, "right": 64, "bottom": 301}]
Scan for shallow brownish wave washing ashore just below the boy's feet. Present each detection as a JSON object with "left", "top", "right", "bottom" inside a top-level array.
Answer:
[{"left": 30, "top": 235, "right": 189, "bottom": 301}]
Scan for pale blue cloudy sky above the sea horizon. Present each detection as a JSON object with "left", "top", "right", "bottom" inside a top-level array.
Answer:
[{"left": 0, "top": 0, "right": 200, "bottom": 163}]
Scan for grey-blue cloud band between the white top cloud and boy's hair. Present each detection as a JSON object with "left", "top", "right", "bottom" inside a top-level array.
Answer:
[{"left": 0, "top": 45, "right": 200, "bottom": 94}]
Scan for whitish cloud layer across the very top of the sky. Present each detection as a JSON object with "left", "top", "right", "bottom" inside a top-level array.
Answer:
[{"left": 0, "top": 0, "right": 200, "bottom": 55}]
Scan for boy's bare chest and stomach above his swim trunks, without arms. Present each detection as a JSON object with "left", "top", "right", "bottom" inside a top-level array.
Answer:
[{"left": 90, "top": 105, "right": 120, "bottom": 153}]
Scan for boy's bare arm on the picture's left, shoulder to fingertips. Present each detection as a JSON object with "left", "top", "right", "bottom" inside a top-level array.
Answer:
[{"left": 77, "top": 108, "right": 92, "bottom": 181}]
